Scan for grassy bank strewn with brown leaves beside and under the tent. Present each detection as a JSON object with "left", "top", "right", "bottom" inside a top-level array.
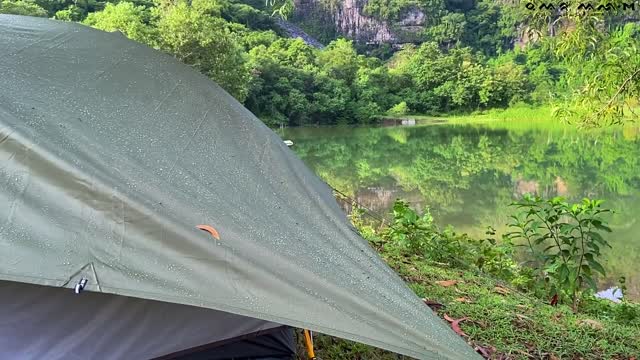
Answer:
[{"left": 299, "top": 243, "right": 640, "bottom": 360}]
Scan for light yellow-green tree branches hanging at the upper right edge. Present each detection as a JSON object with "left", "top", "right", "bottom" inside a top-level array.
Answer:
[{"left": 528, "top": 0, "right": 640, "bottom": 126}]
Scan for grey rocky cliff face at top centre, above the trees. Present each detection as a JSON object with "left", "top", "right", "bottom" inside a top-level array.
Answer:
[{"left": 294, "top": 0, "right": 425, "bottom": 44}]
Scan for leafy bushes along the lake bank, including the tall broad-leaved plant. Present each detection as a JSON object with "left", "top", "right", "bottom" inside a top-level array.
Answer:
[{"left": 368, "top": 196, "right": 611, "bottom": 311}]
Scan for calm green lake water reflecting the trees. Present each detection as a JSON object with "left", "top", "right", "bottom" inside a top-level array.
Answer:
[{"left": 280, "top": 124, "right": 640, "bottom": 299}]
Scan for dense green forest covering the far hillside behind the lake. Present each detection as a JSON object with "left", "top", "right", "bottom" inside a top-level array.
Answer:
[{"left": 0, "top": 0, "right": 640, "bottom": 126}]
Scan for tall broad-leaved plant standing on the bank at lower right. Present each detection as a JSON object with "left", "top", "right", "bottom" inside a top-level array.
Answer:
[{"left": 507, "top": 195, "right": 611, "bottom": 311}]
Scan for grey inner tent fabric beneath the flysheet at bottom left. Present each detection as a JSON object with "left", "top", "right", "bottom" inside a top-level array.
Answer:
[{"left": 0, "top": 281, "right": 281, "bottom": 360}]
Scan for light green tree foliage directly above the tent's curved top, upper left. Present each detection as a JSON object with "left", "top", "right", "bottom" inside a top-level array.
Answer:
[{"left": 84, "top": 0, "right": 249, "bottom": 101}]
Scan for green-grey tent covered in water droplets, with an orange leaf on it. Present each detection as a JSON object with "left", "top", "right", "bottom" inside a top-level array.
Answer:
[{"left": 0, "top": 15, "right": 478, "bottom": 359}]
